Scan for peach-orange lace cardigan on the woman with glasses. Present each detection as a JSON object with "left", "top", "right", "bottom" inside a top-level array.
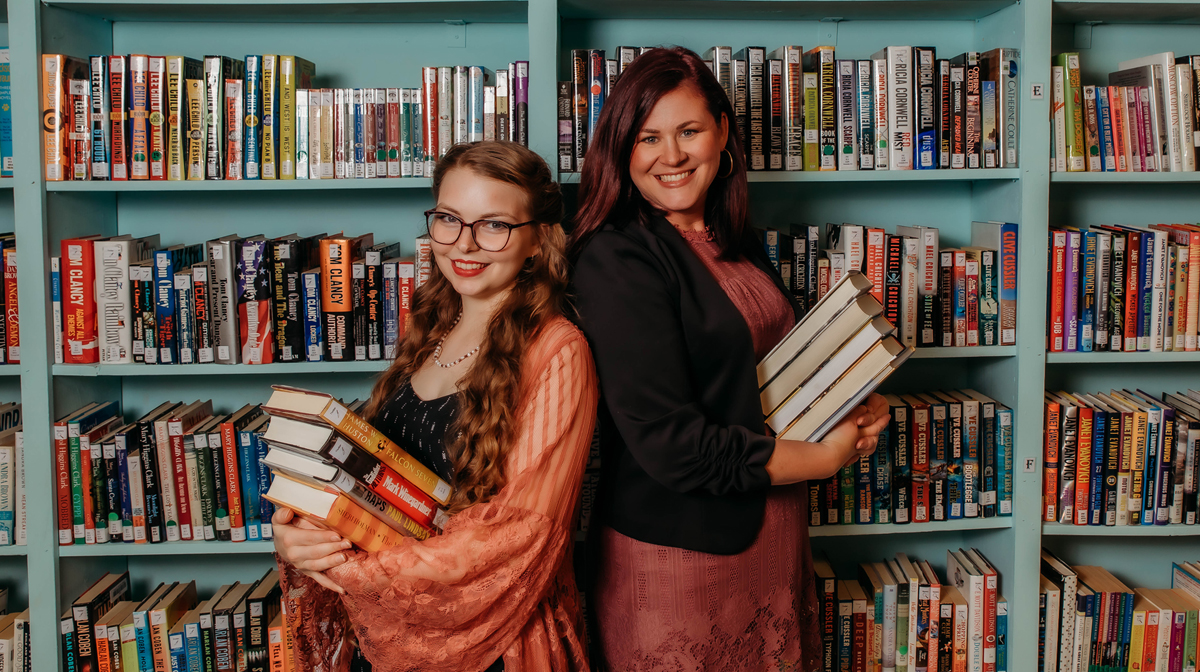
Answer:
[{"left": 280, "top": 318, "right": 599, "bottom": 672}]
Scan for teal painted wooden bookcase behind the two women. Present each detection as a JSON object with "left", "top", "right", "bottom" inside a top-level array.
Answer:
[{"left": 0, "top": 0, "right": 1200, "bottom": 672}]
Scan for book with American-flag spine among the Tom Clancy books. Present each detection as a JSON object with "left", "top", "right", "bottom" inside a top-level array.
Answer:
[{"left": 236, "top": 236, "right": 275, "bottom": 364}]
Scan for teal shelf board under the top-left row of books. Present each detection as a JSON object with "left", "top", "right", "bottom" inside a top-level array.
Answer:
[{"left": 46, "top": 178, "right": 430, "bottom": 192}]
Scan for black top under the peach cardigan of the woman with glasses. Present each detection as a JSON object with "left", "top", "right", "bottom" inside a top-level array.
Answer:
[{"left": 373, "top": 383, "right": 458, "bottom": 482}]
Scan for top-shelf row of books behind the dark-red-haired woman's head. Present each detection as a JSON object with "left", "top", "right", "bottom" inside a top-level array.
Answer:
[{"left": 558, "top": 46, "right": 1020, "bottom": 172}]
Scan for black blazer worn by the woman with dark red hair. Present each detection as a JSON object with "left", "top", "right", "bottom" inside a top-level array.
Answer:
[{"left": 574, "top": 217, "right": 799, "bottom": 554}]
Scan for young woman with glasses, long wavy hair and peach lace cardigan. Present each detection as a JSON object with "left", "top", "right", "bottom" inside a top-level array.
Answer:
[{"left": 271, "top": 142, "right": 598, "bottom": 672}]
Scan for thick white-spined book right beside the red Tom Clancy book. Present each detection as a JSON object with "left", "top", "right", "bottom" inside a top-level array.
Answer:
[{"left": 92, "top": 239, "right": 133, "bottom": 364}]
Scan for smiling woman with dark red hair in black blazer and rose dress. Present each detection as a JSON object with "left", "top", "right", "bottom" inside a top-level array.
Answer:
[{"left": 572, "top": 47, "right": 888, "bottom": 671}]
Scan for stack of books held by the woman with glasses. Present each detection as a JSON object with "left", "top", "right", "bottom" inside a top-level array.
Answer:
[{"left": 263, "top": 385, "right": 450, "bottom": 552}]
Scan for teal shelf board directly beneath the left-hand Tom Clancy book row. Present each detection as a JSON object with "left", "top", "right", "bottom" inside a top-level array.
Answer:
[{"left": 53, "top": 359, "right": 391, "bottom": 378}]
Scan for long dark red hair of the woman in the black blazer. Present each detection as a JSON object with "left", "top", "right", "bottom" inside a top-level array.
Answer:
[{"left": 571, "top": 47, "right": 750, "bottom": 258}]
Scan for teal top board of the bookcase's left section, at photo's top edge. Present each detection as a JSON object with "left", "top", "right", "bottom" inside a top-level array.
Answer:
[{"left": 43, "top": 0, "right": 528, "bottom": 23}]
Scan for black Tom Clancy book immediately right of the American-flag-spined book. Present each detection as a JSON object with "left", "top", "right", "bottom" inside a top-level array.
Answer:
[{"left": 271, "top": 234, "right": 325, "bottom": 361}]
